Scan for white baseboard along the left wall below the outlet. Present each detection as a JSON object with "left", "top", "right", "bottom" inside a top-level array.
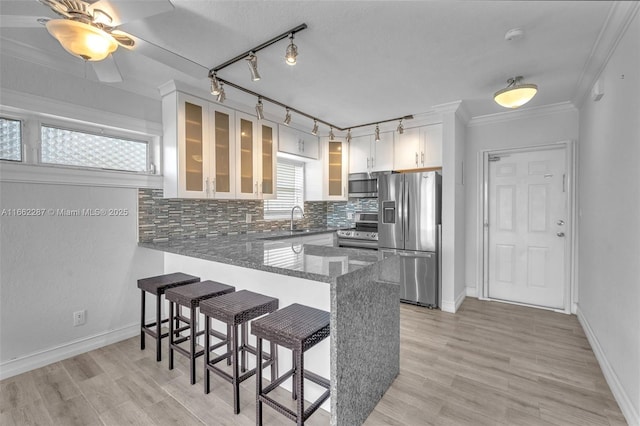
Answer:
[{"left": 0, "top": 323, "right": 140, "bottom": 380}]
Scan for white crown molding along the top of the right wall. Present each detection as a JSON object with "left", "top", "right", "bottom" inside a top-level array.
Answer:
[{"left": 573, "top": 1, "right": 640, "bottom": 108}]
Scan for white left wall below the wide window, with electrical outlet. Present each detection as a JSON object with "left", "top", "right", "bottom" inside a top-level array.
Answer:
[{"left": 0, "top": 182, "right": 163, "bottom": 377}]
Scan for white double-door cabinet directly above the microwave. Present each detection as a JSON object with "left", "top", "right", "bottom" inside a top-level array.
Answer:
[{"left": 349, "top": 132, "right": 394, "bottom": 173}]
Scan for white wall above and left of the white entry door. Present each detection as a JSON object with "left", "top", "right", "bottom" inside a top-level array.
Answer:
[{"left": 464, "top": 104, "right": 578, "bottom": 296}]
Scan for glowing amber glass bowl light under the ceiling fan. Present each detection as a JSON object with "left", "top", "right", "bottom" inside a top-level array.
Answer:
[{"left": 45, "top": 19, "right": 118, "bottom": 61}]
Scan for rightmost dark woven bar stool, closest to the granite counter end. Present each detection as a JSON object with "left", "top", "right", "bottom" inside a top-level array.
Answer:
[{"left": 251, "top": 303, "right": 330, "bottom": 425}]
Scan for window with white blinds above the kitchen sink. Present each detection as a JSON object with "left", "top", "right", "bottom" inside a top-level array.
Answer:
[{"left": 264, "top": 159, "right": 304, "bottom": 219}]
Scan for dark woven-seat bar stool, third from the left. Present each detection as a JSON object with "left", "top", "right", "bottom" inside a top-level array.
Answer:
[{"left": 200, "top": 290, "right": 279, "bottom": 414}]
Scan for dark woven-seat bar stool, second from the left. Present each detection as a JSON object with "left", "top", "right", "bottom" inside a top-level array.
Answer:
[{"left": 164, "top": 280, "right": 236, "bottom": 385}]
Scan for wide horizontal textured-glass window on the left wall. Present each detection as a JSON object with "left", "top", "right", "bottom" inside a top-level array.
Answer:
[{"left": 40, "top": 125, "right": 149, "bottom": 172}]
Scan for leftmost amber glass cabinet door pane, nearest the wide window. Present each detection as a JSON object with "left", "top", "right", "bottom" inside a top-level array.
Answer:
[{"left": 183, "top": 101, "right": 205, "bottom": 193}]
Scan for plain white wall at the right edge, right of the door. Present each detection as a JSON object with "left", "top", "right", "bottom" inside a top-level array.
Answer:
[{"left": 578, "top": 10, "right": 640, "bottom": 425}]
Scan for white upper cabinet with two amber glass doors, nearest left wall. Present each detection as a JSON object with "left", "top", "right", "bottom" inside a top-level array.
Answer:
[{"left": 162, "top": 91, "right": 235, "bottom": 198}]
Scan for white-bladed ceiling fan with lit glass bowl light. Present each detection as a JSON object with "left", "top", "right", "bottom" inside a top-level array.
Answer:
[{"left": 0, "top": 0, "right": 173, "bottom": 83}]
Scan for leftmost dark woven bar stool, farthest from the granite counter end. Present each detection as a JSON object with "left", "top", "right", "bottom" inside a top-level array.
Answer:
[{"left": 138, "top": 272, "right": 200, "bottom": 361}]
